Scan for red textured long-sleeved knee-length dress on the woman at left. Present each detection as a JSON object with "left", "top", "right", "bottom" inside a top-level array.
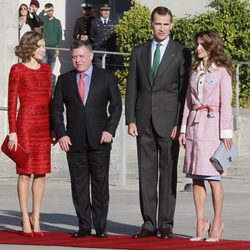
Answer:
[{"left": 8, "top": 63, "right": 51, "bottom": 174}]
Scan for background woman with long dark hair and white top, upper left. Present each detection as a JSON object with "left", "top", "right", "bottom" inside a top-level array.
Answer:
[{"left": 18, "top": 3, "right": 31, "bottom": 38}]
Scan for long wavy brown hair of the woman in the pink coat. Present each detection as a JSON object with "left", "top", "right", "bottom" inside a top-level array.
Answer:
[{"left": 193, "top": 30, "right": 233, "bottom": 76}]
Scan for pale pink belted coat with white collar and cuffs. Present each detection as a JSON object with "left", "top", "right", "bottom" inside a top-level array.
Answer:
[{"left": 181, "top": 64, "right": 233, "bottom": 176}]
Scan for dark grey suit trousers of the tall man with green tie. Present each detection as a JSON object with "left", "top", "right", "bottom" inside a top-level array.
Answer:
[{"left": 137, "top": 121, "right": 179, "bottom": 231}]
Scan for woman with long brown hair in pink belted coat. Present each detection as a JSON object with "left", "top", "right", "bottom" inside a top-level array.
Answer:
[{"left": 179, "top": 30, "right": 233, "bottom": 242}]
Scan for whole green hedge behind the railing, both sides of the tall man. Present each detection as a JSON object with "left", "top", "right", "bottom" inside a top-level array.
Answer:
[{"left": 115, "top": 0, "right": 250, "bottom": 106}]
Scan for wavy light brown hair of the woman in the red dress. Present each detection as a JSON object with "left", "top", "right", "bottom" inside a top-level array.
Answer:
[{"left": 15, "top": 31, "right": 43, "bottom": 62}]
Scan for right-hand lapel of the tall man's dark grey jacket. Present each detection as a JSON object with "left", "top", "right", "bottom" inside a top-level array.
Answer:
[{"left": 155, "top": 39, "right": 175, "bottom": 80}]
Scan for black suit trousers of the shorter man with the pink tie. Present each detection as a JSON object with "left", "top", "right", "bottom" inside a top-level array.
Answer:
[{"left": 67, "top": 150, "right": 110, "bottom": 232}]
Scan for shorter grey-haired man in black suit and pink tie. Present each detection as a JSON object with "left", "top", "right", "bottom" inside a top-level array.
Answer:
[{"left": 52, "top": 40, "right": 122, "bottom": 237}]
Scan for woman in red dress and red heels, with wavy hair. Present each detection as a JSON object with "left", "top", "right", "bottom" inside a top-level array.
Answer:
[{"left": 8, "top": 31, "right": 51, "bottom": 236}]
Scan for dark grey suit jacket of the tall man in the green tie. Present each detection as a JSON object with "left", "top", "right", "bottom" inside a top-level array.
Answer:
[{"left": 125, "top": 39, "right": 191, "bottom": 137}]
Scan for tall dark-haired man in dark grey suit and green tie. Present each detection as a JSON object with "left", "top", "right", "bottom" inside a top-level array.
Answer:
[{"left": 125, "top": 7, "right": 190, "bottom": 238}]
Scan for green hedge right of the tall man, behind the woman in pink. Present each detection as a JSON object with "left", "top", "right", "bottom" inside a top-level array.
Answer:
[{"left": 172, "top": 0, "right": 250, "bottom": 106}]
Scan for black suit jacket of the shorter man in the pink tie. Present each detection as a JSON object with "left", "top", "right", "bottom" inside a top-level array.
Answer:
[{"left": 52, "top": 68, "right": 122, "bottom": 152}]
